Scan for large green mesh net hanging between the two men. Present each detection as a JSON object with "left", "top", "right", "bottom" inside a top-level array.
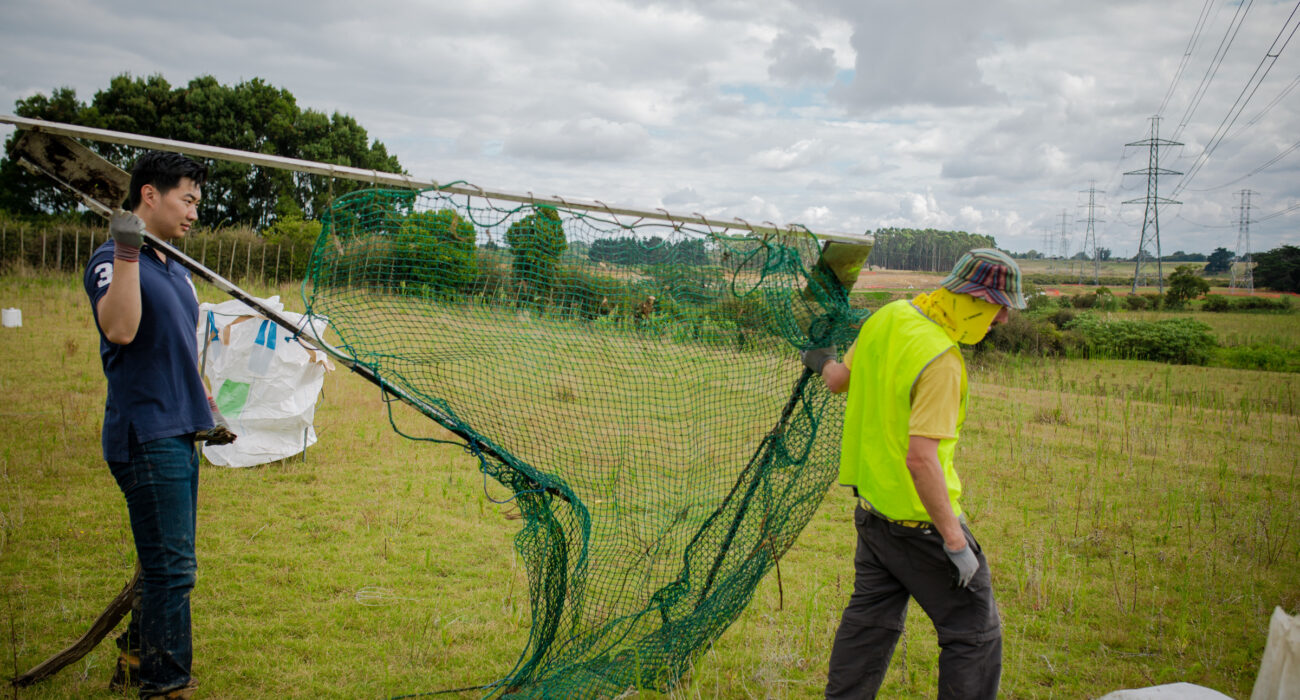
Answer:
[{"left": 304, "top": 190, "right": 868, "bottom": 697}]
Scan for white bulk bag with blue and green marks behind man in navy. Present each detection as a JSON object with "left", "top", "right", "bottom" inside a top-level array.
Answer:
[{"left": 199, "top": 297, "right": 334, "bottom": 467}]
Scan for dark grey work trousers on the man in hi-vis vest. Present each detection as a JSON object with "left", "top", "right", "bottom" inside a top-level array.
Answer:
[{"left": 826, "top": 506, "right": 1002, "bottom": 700}]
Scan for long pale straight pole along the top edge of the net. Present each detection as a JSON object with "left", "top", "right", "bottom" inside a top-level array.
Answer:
[{"left": 0, "top": 114, "right": 872, "bottom": 243}]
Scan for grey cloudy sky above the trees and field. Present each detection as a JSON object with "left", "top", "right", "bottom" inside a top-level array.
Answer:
[{"left": 0, "top": 0, "right": 1300, "bottom": 255}]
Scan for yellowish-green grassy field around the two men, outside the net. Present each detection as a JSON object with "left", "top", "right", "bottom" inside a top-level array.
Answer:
[{"left": 0, "top": 272, "right": 1300, "bottom": 699}]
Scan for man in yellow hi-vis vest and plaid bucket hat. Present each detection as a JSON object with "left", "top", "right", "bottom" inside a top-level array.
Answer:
[{"left": 802, "top": 249, "right": 1024, "bottom": 699}]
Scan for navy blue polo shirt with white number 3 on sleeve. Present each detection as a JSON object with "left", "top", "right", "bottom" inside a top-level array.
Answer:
[{"left": 83, "top": 241, "right": 212, "bottom": 462}]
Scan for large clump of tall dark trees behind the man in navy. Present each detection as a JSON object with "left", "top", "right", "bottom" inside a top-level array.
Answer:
[{"left": 0, "top": 74, "right": 403, "bottom": 230}]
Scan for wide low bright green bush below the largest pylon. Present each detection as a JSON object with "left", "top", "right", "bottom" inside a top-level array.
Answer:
[{"left": 1070, "top": 316, "right": 1218, "bottom": 364}]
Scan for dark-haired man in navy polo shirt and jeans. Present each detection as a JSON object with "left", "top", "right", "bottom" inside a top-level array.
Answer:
[{"left": 85, "top": 151, "right": 234, "bottom": 699}]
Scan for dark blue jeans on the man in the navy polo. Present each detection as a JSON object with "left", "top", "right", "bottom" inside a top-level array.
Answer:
[{"left": 108, "top": 432, "right": 199, "bottom": 696}]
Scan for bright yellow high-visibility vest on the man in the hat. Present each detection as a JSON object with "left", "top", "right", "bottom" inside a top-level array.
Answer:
[{"left": 840, "top": 301, "right": 967, "bottom": 520}]
